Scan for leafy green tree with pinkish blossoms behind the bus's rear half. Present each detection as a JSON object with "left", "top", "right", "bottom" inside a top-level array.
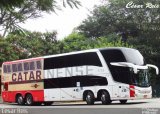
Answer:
[{"left": 5, "top": 31, "right": 59, "bottom": 59}]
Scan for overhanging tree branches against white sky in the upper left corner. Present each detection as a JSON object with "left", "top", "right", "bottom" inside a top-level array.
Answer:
[{"left": 0, "top": 0, "right": 81, "bottom": 36}]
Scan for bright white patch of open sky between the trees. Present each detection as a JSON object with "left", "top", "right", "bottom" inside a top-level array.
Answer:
[{"left": 20, "top": 0, "right": 101, "bottom": 40}]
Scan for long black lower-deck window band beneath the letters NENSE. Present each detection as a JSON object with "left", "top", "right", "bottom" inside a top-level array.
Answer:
[{"left": 44, "top": 76, "right": 108, "bottom": 89}]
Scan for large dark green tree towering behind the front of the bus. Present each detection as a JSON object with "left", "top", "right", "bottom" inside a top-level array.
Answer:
[{"left": 78, "top": 0, "right": 160, "bottom": 96}]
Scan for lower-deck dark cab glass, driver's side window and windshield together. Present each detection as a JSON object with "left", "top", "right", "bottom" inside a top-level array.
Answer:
[{"left": 107, "top": 66, "right": 150, "bottom": 87}]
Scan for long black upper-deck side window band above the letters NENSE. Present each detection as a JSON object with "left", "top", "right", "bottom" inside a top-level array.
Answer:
[{"left": 44, "top": 52, "right": 102, "bottom": 69}]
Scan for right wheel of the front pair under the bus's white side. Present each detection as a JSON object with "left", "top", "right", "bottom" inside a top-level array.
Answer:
[{"left": 101, "top": 91, "right": 111, "bottom": 105}]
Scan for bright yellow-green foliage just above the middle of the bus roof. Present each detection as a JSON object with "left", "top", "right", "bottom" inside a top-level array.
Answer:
[{"left": 62, "top": 33, "right": 132, "bottom": 52}]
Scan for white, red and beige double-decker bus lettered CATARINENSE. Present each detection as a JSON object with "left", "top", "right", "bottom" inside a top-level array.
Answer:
[{"left": 1, "top": 47, "right": 159, "bottom": 105}]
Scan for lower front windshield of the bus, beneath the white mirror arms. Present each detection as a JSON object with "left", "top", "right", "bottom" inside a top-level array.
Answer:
[{"left": 131, "top": 69, "right": 150, "bottom": 87}]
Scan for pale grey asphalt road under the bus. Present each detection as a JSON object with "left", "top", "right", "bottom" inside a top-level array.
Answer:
[{"left": 0, "top": 98, "right": 160, "bottom": 114}]
